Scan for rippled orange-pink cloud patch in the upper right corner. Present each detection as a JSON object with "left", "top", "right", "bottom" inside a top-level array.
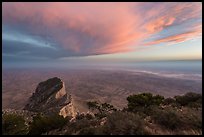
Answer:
[{"left": 145, "top": 3, "right": 202, "bottom": 33}]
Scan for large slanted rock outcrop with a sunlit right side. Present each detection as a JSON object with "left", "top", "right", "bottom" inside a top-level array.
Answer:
[{"left": 24, "top": 77, "right": 76, "bottom": 117}]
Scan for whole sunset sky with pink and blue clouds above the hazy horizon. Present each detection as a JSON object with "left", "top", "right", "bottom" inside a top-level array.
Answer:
[{"left": 2, "top": 2, "right": 202, "bottom": 67}]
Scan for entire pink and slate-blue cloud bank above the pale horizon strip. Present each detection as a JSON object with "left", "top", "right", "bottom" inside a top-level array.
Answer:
[{"left": 2, "top": 2, "right": 202, "bottom": 58}]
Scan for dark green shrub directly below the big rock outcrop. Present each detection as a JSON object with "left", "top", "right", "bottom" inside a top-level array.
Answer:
[{"left": 29, "top": 114, "right": 69, "bottom": 135}]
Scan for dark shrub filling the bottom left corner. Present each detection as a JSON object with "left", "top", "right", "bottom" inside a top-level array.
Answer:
[{"left": 2, "top": 114, "right": 28, "bottom": 135}]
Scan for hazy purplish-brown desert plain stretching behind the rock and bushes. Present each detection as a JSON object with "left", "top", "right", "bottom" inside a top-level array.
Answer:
[{"left": 2, "top": 65, "right": 202, "bottom": 111}]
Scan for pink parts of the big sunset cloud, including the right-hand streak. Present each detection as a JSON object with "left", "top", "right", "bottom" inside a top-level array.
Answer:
[{"left": 3, "top": 2, "right": 202, "bottom": 55}]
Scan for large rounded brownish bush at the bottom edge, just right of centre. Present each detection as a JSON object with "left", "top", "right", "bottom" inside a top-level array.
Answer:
[{"left": 103, "top": 111, "right": 147, "bottom": 135}]
